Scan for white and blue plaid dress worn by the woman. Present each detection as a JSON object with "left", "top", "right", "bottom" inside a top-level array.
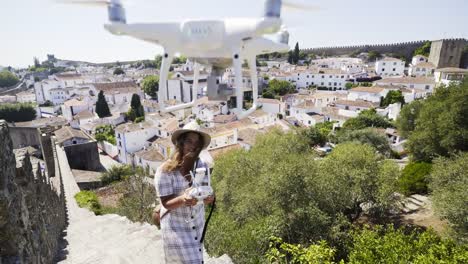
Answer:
[{"left": 154, "top": 162, "right": 208, "bottom": 264}]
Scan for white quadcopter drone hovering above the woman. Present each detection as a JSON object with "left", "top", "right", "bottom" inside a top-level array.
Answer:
[{"left": 60, "top": 0, "right": 307, "bottom": 120}]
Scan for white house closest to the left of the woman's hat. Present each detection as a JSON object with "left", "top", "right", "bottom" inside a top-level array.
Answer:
[{"left": 115, "top": 122, "right": 158, "bottom": 164}]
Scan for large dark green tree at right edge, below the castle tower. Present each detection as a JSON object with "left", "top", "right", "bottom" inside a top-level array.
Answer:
[{"left": 401, "top": 79, "right": 468, "bottom": 162}]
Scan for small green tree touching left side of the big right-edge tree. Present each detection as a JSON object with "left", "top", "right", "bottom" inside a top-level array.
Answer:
[{"left": 396, "top": 100, "right": 424, "bottom": 138}]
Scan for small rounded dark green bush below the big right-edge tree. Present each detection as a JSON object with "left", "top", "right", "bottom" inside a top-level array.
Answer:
[{"left": 399, "top": 162, "right": 432, "bottom": 195}]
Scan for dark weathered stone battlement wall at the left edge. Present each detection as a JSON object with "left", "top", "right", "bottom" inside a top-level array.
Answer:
[{"left": 0, "top": 121, "right": 66, "bottom": 264}]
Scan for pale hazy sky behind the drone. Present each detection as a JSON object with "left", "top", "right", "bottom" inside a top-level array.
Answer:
[{"left": 0, "top": 0, "right": 468, "bottom": 67}]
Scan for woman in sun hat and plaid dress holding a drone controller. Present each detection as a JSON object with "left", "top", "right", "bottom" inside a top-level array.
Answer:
[{"left": 155, "top": 124, "right": 214, "bottom": 264}]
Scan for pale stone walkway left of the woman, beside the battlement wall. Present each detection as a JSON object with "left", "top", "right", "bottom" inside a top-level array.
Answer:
[{"left": 56, "top": 146, "right": 232, "bottom": 264}]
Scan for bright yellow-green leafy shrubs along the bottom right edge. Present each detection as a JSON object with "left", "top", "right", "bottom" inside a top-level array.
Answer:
[{"left": 267, "top": 226, "right": 468, "bottom": 264}]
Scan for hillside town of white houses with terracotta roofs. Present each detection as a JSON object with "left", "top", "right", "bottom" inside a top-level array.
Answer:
[{"left": 0, "top": 39, "right": 468, "bottom": 263}]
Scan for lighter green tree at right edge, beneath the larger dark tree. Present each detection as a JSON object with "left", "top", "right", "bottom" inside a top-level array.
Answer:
[{"left": 429, "top": 152, "right": 468, "bottom": 244}]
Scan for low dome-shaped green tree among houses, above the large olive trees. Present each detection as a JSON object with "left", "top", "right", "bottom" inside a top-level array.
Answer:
[{"left": 343, "top": 109, "right": 392, "bottom": 130}]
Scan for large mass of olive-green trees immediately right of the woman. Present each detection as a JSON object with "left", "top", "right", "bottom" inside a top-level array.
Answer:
[{"left": 206, "top": 131, "right": 399, "bottom": 263}]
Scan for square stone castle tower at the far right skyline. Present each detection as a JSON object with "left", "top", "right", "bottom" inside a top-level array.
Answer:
[{"left": 429, "top": 39, "right": 468, "bottom": 68}]
